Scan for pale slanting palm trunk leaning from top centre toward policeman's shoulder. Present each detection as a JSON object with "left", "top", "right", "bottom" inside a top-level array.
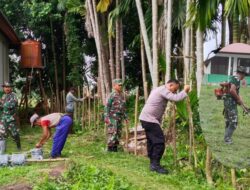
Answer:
[{"left": 135, "top": 0, "right": 153, "bottom": 80}]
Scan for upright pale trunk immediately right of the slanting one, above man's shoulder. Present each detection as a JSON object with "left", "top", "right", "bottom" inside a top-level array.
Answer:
[{"left": 152, "top": 0, "right": 159, "bottom": 88}]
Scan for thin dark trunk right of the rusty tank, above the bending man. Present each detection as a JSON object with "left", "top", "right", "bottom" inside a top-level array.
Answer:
[{"left": 50, "top": 16, "right": 60, "bottom": 111}]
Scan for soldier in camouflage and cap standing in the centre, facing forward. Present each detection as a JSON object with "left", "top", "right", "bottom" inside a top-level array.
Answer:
[{"left": 105, "top": 79, "right": 128, "bottom": 152}]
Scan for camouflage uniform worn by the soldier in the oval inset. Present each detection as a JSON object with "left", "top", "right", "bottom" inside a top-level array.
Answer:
[{"left": 223, "top": 76, "right": 240, "bottom": 142}]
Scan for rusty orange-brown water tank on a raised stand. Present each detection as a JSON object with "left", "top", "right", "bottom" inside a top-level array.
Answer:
[{"left": 21, "top": 40, "right": 43, "bottom": 69}]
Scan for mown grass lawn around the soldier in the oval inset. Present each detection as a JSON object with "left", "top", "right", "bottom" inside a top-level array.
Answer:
[{"left": 200, "top": 86, "right": 250, "bottom": 168}]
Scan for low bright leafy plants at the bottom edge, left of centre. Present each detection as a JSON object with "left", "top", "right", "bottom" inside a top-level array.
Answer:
[{"left": 34, "top": 162, "right": 134, "bottom": 190}]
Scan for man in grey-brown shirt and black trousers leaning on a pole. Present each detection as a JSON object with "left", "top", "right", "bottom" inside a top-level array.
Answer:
[{"left": 139, "top": 79, "right": 190, "bottom": 174}]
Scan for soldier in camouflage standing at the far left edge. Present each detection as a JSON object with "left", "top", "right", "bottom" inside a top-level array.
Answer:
[{"left": 0, "top": 82, "right": 21, "bottom": 150}]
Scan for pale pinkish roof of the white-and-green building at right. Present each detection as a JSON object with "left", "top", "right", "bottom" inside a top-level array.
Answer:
[{"left": 219, "top": 43, "right": 250, "bottom": 54}]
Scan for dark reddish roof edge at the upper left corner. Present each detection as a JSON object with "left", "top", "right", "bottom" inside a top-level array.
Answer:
[{"left": 0, "top": 11, "right": 20, "bottom": 47}]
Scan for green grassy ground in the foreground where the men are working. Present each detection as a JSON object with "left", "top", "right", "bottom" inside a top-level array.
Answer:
[{"left": 0, "top": 124, "right": 233, "bottom": 190}]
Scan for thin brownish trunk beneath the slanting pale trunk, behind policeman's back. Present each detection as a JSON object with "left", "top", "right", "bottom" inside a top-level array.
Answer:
[{"left": 141, "top": 32, "right": 148, "bottom": 102}]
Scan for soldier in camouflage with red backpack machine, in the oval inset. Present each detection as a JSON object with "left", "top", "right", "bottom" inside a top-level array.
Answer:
[{"left": 221, "top": 66, "right": 246, "bottom": 144}]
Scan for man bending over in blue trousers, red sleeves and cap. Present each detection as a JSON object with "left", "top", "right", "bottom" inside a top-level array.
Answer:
[{"left": 30, "top": 113, "right": 72, "bottom": 158}]
